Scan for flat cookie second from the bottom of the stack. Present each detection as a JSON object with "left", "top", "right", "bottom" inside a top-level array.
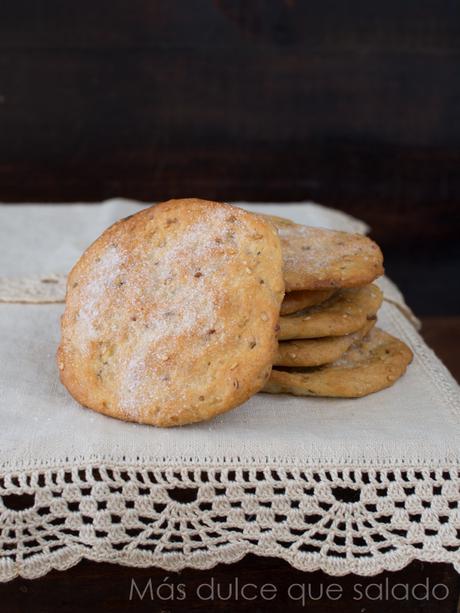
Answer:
[{"left": 274, "top": 318, "right": 377, "bottom": 368}]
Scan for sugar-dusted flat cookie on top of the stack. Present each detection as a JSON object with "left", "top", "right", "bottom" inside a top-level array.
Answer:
[{"left": 260, "top": 215, "right": 383, "bottom": 292}]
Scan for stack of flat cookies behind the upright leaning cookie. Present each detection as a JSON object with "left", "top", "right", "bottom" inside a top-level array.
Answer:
[{"left": 264, "top": 217, "right": 412, "bottom": 398}]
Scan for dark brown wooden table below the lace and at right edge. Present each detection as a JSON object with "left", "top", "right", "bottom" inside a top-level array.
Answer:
[{"left": 0, "top": 316, "right": 460, "bottom": 613}]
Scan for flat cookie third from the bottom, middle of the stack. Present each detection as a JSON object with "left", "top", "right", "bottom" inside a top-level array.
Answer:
[{"left": 278, "top": 285, "right": 383, "bottom": 341}]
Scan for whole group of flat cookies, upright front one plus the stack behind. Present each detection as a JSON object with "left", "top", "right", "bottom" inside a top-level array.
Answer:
[{"left": 58, "top": 198, "right": 412, "bottom": 426}]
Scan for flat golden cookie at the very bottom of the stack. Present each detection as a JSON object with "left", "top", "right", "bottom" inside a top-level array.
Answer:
[{"left": 263, "top": 328, "right": 413, "bottom": 398}]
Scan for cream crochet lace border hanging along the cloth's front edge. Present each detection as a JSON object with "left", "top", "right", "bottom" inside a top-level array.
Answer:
[{"left": 0, "top": 465, "right": 460, "bottom": 581}]
